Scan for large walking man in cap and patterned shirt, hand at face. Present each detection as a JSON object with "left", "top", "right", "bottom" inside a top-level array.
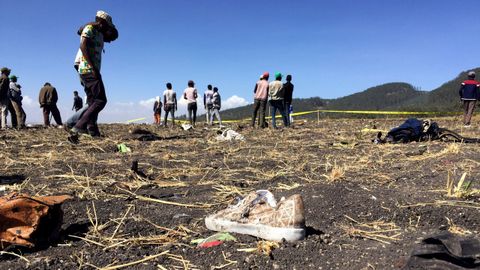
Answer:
[{"left": 71, "top": 11, "right": 118, "bottom": 136}]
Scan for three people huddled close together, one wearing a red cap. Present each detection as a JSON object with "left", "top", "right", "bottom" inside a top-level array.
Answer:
[{"left": 251, "top": 72, "right": 293, "bottom": 129}]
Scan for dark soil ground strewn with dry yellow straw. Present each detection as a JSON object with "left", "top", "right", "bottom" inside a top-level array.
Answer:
[{"left": 0, "top": 118, "right": 480, "bottom": 269}]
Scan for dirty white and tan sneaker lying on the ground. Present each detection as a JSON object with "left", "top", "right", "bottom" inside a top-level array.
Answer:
[{"left": 205, "top": 191, "right": 305, "bottom": 242}]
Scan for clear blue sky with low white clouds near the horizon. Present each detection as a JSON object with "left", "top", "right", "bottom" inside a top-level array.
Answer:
[{"left": 0, "top": 0, "right": 480, "bottom": 123}]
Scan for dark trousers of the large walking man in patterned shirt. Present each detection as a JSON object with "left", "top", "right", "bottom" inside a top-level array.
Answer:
[{"left": 75, "top": 74, "right": 107, "bottom": 132}]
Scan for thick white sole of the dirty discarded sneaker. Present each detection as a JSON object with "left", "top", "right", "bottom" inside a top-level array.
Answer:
[{"left": 205, "top": 216, "right": 305, "bottom": 242}]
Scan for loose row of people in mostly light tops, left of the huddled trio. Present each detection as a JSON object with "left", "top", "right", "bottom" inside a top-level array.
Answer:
[{"left": 153, "top": 80, "right": 222, "bottom": 127}]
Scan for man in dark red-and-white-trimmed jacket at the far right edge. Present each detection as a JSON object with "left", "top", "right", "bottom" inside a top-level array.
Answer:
[{"left": 458, "top": 71, "right": 480, "bottom": 128}]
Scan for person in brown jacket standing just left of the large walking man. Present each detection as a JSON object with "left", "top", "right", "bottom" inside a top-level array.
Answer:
[{"left": 38, "top": 82, "right": 62, "bottom": 127}]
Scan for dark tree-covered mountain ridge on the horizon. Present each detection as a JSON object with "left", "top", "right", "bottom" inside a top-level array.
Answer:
[{"left": 221, "top": 68, "right": 480, "bottom": 119}]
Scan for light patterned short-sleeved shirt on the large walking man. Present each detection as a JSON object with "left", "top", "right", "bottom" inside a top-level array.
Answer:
[{"left": 75, "top": 24, "right": 103, "bottom": 74}]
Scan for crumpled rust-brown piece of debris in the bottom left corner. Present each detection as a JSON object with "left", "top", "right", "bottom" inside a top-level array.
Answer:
[{"left": 0, "top": 193, "right": 71, "bottom": 250}]
